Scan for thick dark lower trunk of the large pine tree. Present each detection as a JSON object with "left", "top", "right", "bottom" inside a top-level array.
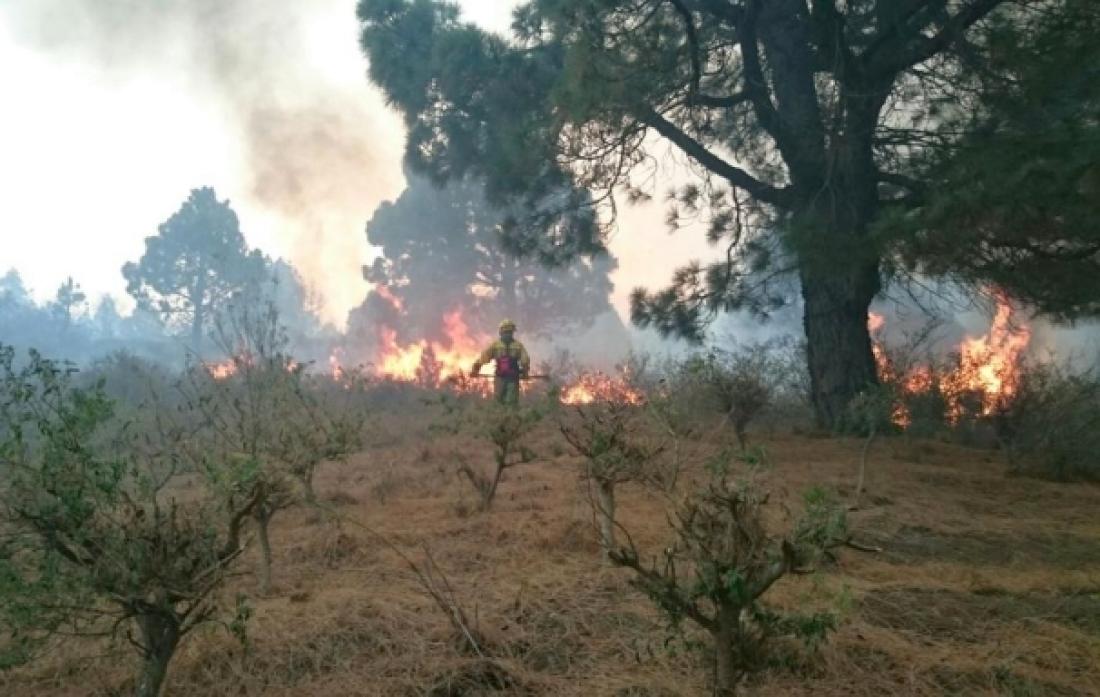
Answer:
[{"left": 802, "top": 262, "right": 879, "bottom": 429}]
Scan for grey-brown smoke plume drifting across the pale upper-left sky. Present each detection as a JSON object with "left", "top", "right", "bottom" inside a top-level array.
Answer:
[{"left": 0, "top": 0, "right": 403, "bottom": 324}]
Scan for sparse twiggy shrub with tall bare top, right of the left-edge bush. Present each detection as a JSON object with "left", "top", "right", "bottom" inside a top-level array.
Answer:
[{"left": 179, "top": 302, "right": 365, "bottom": 591}]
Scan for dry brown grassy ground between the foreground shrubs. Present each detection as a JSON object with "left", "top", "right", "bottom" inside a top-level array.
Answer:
[{"left": 0, "top": 404, "right": 1100, "bottom": 697}]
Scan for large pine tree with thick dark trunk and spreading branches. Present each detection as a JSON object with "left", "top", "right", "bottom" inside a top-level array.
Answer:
[{"left": 359, "top": 0, "right": 1096, "bottom": 425}]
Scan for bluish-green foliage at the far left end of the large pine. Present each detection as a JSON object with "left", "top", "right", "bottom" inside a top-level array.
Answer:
[{"left": 356, "top": 0, "right": 604, "bottom": 266}]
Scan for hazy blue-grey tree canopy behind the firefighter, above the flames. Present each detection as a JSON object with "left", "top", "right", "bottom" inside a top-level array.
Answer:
[{"left": 364, "top": 175, "right": 615, "bottom": 340}]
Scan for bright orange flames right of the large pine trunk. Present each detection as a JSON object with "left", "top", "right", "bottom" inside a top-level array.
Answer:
[{"left": 867, "top": 294, "right": 1031, "bottom": 428}]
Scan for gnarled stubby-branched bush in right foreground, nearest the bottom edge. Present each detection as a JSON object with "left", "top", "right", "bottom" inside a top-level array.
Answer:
[{"left": 611, "top": 476, "right": 845, "bottom": 695}]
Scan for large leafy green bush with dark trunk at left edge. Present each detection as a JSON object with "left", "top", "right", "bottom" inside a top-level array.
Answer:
[{"left": 0, "top": 346, "right": 253, "bottom": 697}]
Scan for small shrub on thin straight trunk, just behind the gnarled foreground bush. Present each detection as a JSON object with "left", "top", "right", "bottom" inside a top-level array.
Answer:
[{"left": 559, "top": 402, "right": 662, "bottom": 554}]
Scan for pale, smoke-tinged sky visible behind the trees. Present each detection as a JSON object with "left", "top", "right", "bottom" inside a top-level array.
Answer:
[{"left": 0, "top": 0, "right": 706, "bottom": 327}]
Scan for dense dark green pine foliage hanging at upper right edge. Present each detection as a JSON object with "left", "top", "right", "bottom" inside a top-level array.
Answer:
[{"left": 881, "top": 0, "right": 1100, "bottom": 318}]
